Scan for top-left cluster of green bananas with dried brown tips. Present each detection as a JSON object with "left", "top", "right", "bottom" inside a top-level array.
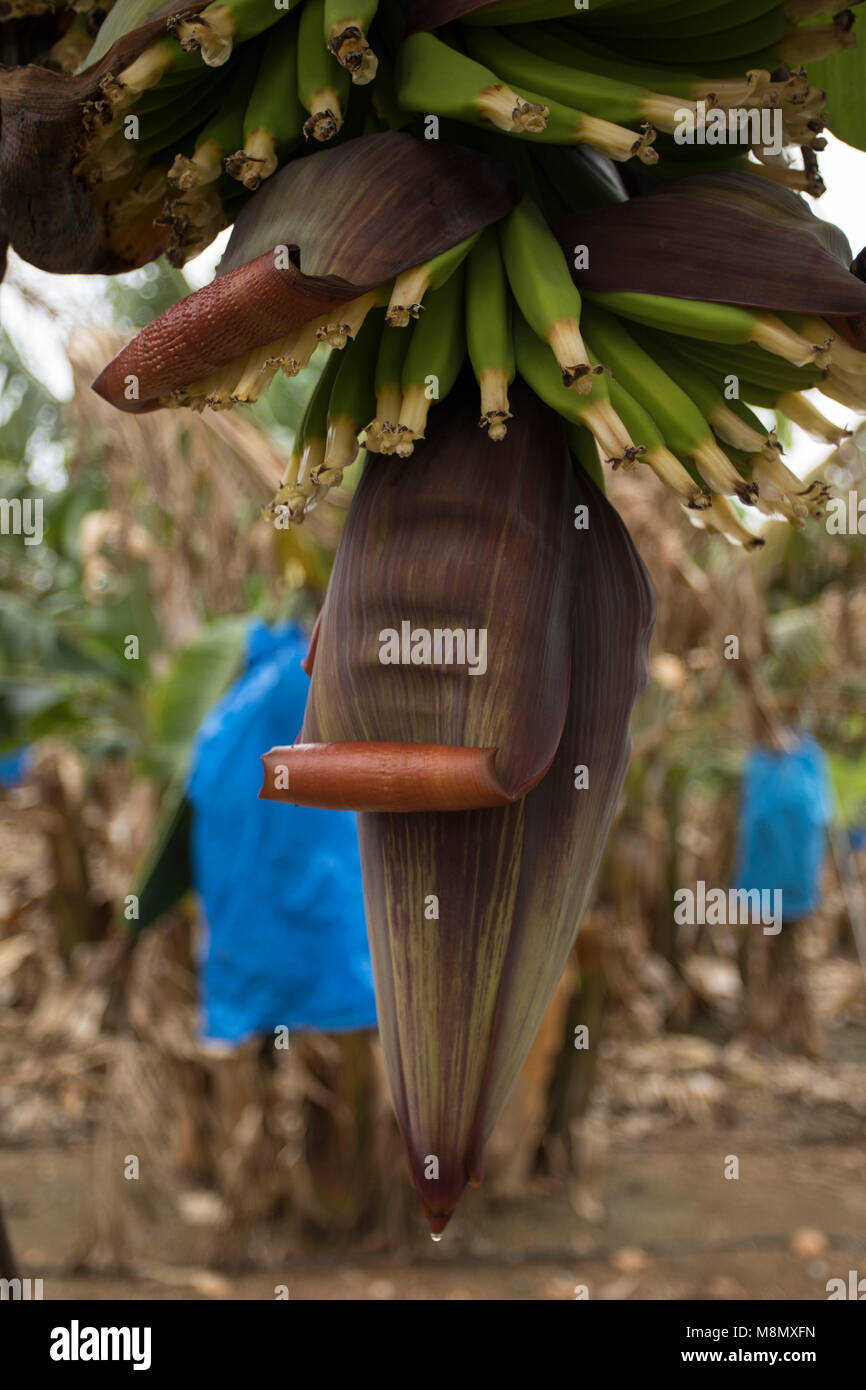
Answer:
[{"left": 71, "top": 0, "right": 382, "bottom": 265}]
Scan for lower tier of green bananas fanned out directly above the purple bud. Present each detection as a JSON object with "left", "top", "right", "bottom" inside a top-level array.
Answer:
[{"left": 147, "top": 177, "right": 866, "bottom": 548}]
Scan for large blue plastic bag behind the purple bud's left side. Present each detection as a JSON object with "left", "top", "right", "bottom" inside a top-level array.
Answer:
[{"left": 188, "top": 624, "right": 375, "bottom": 1041}]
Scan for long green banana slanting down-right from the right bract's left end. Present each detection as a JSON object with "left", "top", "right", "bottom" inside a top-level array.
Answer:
[{"left": 584, "top": 304, "right": 753, "bottom": 502}]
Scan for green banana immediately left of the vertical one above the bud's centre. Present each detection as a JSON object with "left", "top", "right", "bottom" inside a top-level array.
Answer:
[{"left": 395, "top": 263, "right": 466, "bottom": 459}]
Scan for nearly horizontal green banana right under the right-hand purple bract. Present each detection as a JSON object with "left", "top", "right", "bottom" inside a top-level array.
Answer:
[{"left": 587, "top": 291, "right": 815, "bottom": 367}]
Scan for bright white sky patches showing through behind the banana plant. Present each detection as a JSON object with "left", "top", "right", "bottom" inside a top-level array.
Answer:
[{"left": 0, "top": 136, "right": 866, "bottom": 477}]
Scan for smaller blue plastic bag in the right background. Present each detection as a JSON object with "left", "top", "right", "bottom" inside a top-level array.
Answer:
[{"left": 735, "top": 737, "right": 833, "bottom": 922}]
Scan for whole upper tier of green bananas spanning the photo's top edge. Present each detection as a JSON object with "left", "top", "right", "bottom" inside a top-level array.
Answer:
[{"left": 62, "top": 0, "right": 853, "bottom": 275}]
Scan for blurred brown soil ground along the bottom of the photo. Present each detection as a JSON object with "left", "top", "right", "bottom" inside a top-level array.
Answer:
[{"left": 0, "top": 1095, "right": 866, "bottom": 1300}]
